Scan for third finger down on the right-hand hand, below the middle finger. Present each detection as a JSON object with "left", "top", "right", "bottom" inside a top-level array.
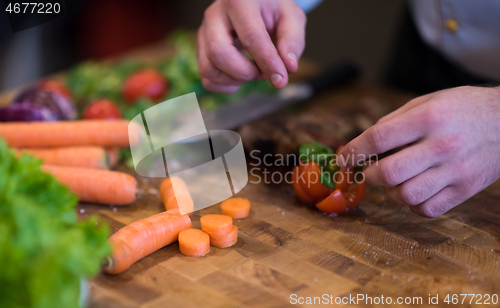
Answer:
[{"left": 385, "top": 167, "right": 450, "bottom": 206}]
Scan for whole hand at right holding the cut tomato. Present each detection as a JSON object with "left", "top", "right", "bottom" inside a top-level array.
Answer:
[{"left": 339, "top": 87, "right": 500, "bottom": 217}]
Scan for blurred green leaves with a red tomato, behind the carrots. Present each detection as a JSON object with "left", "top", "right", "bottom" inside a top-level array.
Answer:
[{"left": 64, "top": 30, "right": 274, "bottom": 120}]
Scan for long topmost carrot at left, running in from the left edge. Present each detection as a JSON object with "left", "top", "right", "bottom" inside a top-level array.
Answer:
[{"left": 0, "top": 120, "right": 139, "bottom": 148}]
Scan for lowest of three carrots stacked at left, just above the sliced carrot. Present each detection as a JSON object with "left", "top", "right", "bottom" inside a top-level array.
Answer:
[{"left": 42, "top": 165, "right": 137, "bottom": 205}]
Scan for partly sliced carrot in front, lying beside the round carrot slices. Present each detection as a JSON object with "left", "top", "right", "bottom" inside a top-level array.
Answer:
[{"left": 104, "top": 209, "right": 192, "bottom": 274}]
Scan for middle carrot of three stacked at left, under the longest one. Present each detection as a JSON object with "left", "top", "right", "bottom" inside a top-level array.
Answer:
[{"left": 16, "top": 146, "right": 109, "bottom": 169}]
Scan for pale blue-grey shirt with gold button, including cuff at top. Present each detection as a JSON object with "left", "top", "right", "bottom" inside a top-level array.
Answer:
[{"left": 296, "top": 0, "right": 500, "bottom": 82}]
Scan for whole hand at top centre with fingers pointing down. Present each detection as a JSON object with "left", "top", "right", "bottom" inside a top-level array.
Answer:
[{"left": 198, "top": 0, "right": 306, "bottom": 93}]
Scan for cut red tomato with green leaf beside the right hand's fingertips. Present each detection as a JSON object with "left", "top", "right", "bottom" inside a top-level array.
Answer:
[{"left": 292, "top": 141, "right": 366, "bottom": 214}]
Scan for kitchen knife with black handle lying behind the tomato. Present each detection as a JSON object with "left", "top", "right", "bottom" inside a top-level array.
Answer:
[{"left": 203, "top": 63, "right": 359, "bottom": 130}]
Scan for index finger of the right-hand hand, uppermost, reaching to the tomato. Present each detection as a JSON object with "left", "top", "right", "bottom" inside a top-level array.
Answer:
[{"left": 338, "top": 106, "right": 426, "bottom": 169}]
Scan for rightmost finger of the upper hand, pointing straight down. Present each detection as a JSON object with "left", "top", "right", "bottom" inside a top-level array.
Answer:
[{"left": 276, "top": 1, "right": 307, "bottom": 73}]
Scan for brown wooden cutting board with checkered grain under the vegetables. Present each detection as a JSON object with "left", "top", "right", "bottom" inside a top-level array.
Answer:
[{"left": 78, "top": 83, "right": 500, "bottom": 308}]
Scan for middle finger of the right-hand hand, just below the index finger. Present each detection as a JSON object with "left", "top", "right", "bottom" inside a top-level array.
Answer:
[{"left": 363, "top": 142, "right": 439, "bottom": 186}]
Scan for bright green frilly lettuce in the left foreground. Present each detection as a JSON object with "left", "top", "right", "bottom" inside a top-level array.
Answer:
[{"left": 0, "top": 140, "right": 110, "bottom": 308}]
